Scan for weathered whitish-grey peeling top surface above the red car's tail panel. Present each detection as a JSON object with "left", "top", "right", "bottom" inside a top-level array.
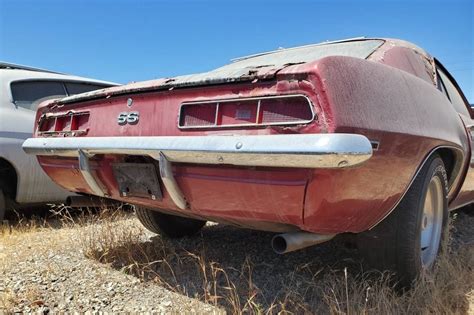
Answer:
[{"left": 58, "top": 38, "right": 384, "bottom": 104}]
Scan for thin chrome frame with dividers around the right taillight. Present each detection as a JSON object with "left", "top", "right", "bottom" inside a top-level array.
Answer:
[{"left": 178, "top": 94, "right": 316, "bottom": 129}]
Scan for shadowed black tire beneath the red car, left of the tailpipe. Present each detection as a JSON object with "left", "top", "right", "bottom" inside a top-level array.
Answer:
[{"left": 135, "top": 207, "right": 206, "bottom": 238}]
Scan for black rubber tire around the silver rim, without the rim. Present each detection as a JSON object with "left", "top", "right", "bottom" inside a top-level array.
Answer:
[{"left": 357, "top": 154, "right": 448, "bottom": 288}]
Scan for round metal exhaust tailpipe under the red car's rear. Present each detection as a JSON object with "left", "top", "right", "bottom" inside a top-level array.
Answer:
[{"left": 272, "top": 232, "right": 336, "bottom": 254}]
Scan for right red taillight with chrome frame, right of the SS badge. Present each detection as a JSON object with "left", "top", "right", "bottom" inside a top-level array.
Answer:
[{"left": 179, "top": 95, "right": 314, "bottom": 128}]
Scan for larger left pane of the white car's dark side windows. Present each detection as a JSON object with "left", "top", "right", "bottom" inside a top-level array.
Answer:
[{"left": 11, "top": 81, "right": 67, "bottom": 110}]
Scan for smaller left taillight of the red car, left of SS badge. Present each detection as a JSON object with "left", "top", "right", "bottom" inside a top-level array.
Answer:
[{"left": 38, "top": 112, "right": 89, "bottom": 136}]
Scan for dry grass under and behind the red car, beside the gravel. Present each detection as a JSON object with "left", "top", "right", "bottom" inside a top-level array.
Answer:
[{"left": 80, "top": 212, "right": 474, "bottom": 314}]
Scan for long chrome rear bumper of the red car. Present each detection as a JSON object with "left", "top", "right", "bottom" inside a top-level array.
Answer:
[{"left": 23, "top": 134, "right": 372, "bottom": 168}]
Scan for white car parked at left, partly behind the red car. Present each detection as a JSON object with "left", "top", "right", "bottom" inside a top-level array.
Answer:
[{"left": 0, "top": 62, "right": 117, "bottom": 221}]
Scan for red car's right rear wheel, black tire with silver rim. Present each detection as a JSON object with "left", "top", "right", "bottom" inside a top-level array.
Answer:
[{"left": 358, "top": 155, "right": 448, "bottom": 288}]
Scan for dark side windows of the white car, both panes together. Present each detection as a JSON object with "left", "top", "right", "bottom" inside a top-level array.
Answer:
[{"left": 11, "top": 80, "right": 107, "bottom": 110}]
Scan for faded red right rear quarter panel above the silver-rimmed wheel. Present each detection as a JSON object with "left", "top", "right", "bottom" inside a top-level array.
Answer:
[{"left": 280, "top": 57, "right": 469, "bottom": 232}]
